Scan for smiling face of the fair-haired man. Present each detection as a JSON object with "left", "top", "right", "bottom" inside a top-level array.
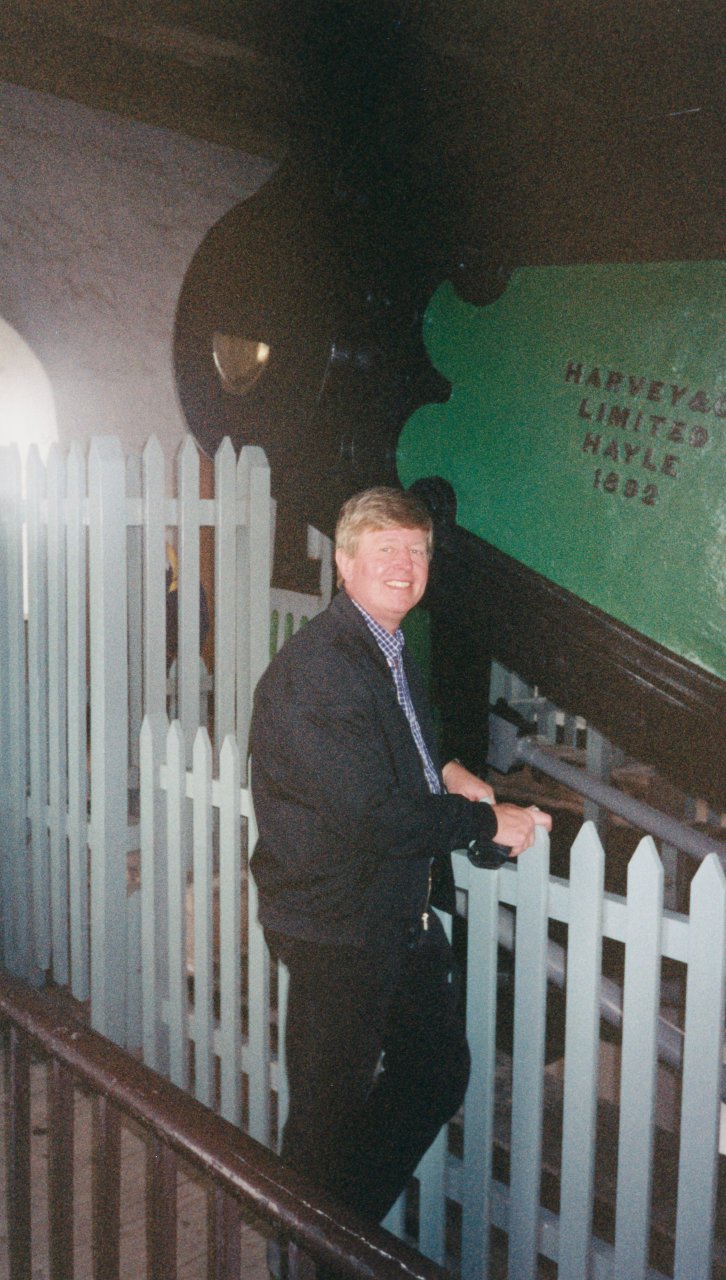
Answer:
[{"left": 335, "top": 526, "right": 429, "bottom": 632}]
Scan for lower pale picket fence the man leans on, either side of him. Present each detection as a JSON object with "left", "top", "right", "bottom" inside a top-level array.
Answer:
[{"left": 141, "top": 718, "right": 726, "bottom": 1280}]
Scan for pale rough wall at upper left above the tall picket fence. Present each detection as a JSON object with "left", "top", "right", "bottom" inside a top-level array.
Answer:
[{"left": 0, "top": 82, "right": 273, "bottom": 458}]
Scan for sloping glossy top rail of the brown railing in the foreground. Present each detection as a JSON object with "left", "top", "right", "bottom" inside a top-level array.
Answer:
[{"left": 0, "top": 973, "right": 446, "bottom": 1280}]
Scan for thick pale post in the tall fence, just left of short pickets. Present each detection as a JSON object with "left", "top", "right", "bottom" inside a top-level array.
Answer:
[{"left": 88, "top": 436, "right": 128, "bottom": 1044}]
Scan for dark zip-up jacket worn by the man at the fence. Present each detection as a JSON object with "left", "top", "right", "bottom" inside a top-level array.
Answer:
[{"left": 250, "top": 591, "right": 496, "bottom": 945}]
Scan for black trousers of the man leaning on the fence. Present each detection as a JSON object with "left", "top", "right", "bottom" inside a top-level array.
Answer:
[{"left": 268, "top": 916, "right": 470, "bottom": 1220}]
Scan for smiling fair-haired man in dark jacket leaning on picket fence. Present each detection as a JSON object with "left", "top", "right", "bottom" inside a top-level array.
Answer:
[{"left": 251, "top": 488, "right": 551, "bottom": 1220}]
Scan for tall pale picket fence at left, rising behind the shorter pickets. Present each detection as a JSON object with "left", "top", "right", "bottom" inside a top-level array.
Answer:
[{"left": 0, "top": 438, "right": 332, "bottom": 1043}]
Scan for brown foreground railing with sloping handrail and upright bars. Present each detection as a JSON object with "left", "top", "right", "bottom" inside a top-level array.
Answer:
[{"left": 0, "top": 973, "right": 446, "bottom": 1280}]
